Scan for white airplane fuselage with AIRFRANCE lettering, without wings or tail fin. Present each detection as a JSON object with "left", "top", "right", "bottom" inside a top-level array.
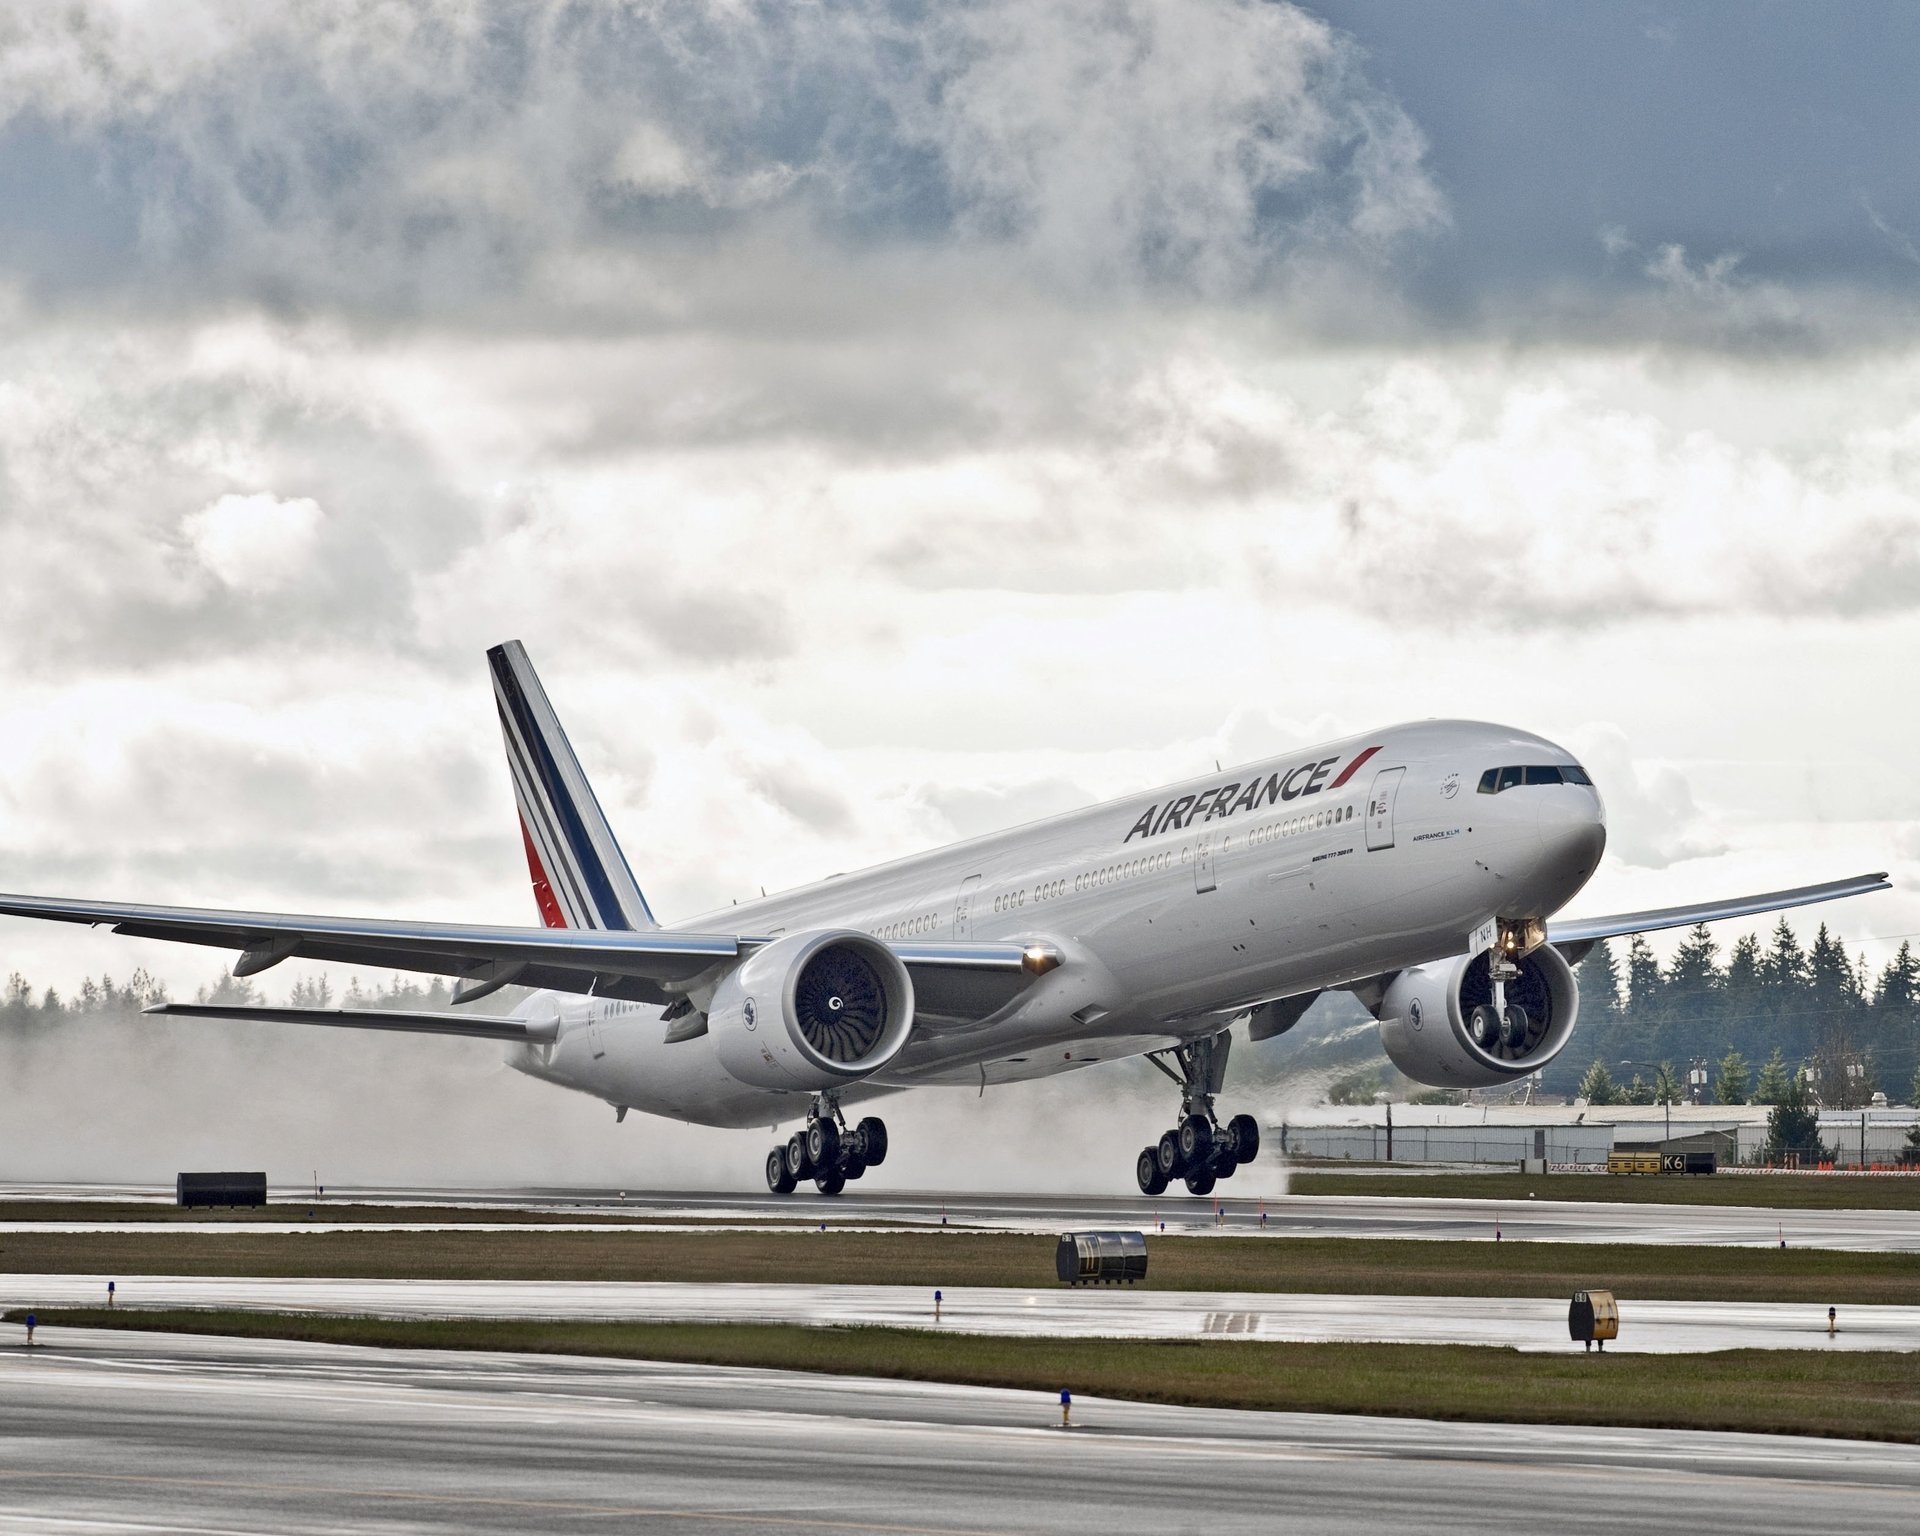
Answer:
[{"left": 513, "top": 720, "right": 1605, "bottom": 1125}]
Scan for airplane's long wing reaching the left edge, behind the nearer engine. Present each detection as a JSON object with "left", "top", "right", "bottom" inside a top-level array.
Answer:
[{"left": 0, "top": 895, "right": 1058, "bottom": 1027}]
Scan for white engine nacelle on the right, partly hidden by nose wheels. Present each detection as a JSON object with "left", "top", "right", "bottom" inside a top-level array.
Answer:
[{"left": 1375, "top": 945, "right": 1580, "bottom": 1089}]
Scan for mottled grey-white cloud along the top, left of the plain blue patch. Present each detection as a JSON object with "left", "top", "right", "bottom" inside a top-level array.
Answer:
[{"left": 0, "top": 0, "right": 1446, "bottom": 324}]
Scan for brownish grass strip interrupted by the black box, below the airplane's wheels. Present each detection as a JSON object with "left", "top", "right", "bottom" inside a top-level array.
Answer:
[{"left": 0, "top": 1229, "right": 1920, "bottom": 1309}]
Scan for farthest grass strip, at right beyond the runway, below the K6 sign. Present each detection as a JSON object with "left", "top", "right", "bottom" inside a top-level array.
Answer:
[{"left": 1286, "top": 1169, "right": 1920, "bottom": 1212}]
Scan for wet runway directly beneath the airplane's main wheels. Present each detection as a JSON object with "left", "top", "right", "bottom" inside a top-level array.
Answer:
[{"left": 11, "top": 1185, "right": 1920, "bottom": 1254}]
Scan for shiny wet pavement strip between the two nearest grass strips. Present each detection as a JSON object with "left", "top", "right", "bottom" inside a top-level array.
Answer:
[{"left": 0, "top": 1275, "right": 1920, "bottom": 1354}]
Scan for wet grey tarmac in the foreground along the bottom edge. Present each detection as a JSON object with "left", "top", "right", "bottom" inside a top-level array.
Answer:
[{"left": 0, "top": 1332, "right": 1920, "bottom": 1536}]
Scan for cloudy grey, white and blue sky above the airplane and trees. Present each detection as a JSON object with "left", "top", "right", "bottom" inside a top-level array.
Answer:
[{"left": 0, "top": 0, "right": 1920, "bottom": 991}]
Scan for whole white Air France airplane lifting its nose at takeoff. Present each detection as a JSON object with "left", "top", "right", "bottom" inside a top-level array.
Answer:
[{"left": 0, "top": 641, "right": 1889, "bottom": 1194}]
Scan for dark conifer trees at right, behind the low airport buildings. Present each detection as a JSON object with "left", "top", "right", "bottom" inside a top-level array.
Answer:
[{"left": 1542, "top": 918, "right": 1920, "bottom": 1110}]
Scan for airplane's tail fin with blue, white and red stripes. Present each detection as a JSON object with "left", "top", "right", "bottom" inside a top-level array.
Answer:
[{"left": 486, "top": 639, "right": 659, "bottom": 929}]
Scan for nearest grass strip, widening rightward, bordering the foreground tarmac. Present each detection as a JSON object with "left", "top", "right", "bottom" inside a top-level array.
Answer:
[{"left": 8, "top": 1309, "right": 1920, "bottom": 1442}]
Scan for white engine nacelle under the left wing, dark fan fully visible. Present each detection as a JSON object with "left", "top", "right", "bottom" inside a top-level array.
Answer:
[{"left": 707, "top": 929, "right": 914, "bottom": 1092}]
